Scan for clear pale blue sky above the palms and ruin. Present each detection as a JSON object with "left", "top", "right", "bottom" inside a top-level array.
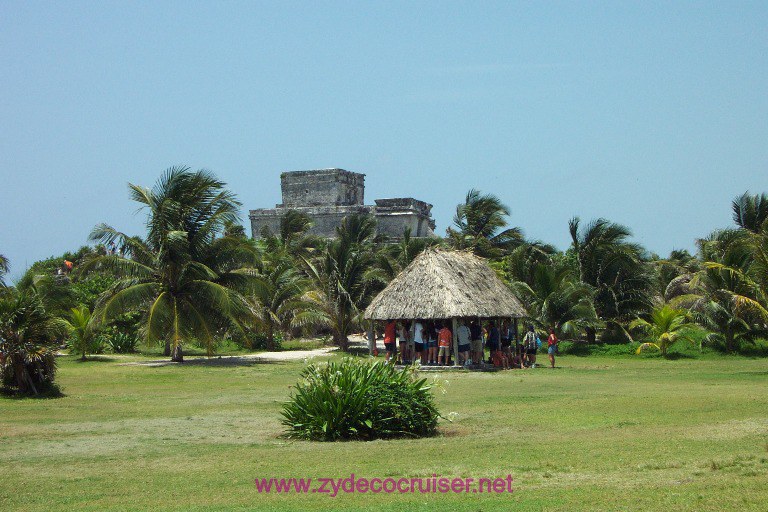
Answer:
[{"left": 0, "top": 0, "right": 768, "bottom": 277}]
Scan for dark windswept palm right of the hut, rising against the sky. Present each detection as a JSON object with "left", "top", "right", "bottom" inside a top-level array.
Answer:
[{"left": 568, "top": 217, "right": 653, "bottom": 342}]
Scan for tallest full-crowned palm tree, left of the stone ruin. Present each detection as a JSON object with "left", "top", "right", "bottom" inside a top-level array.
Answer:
[{"left": 88, "top": 167, "right": 255, "bottom": 362}]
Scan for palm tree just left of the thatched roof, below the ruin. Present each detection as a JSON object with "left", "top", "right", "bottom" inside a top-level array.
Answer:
[{"left": 305, "top": 214, "right": 386, "bottom": 351}]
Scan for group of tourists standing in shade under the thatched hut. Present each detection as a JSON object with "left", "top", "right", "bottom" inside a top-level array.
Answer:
[{"left": 384, "top": 319, "right": 558, "bottom": 369}]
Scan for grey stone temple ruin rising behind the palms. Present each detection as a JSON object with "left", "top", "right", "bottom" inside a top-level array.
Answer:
[{"left": 249, "top": 169, "right": 435, "bottom": 239}]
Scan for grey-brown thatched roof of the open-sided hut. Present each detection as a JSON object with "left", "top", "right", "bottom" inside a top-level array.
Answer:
[{"left": 365, "top": 248, "right": 526, "bottom": 320}]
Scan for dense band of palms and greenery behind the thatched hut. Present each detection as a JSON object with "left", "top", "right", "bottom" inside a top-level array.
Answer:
[{"left": 6, "top": 167, "right": 768, "bottom": 368}]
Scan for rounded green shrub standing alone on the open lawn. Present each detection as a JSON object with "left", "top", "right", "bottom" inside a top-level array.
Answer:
[{"left": 282, "top": 358, "right": 440, "bottom": 441}]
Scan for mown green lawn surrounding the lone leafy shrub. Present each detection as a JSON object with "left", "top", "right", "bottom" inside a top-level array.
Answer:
[{"left": 0, "top": 350, "right": 768, "bottom": 512}]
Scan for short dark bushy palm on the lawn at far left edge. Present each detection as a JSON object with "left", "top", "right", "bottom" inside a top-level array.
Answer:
[{"left": 0, "top": 289, "right": 66, "bottom": 395}]
